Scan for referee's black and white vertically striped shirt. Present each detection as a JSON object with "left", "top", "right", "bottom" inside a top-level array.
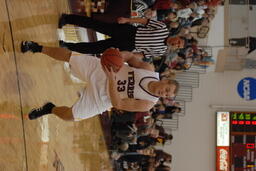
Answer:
[{"left": 135, "top": 20, "right": 169, "bottom": 61}]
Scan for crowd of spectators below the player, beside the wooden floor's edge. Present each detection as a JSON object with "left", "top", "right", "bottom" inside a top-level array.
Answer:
[{"left": 111, "top": 99, "right": 181, "bottom": 170}]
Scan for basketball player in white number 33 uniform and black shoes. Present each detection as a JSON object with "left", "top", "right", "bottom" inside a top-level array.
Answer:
[{"left": 21, "top": 41, "right": 179, "bottom": 121}]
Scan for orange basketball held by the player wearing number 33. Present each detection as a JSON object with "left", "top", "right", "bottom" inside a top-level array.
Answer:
[{"left": 101, "top": 48, "right": 124, "bottom": 72}]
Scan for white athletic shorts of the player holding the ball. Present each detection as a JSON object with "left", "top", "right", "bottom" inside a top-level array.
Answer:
[{"left": 69, "top": 52, "right": 112, "bottom": 121}]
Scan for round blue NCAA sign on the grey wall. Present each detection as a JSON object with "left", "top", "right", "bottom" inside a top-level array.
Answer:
[{"left": 237, "top": 77, "right": 256, "bottom": 100}]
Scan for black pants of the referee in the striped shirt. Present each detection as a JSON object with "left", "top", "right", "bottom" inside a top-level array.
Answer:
[{"left": 61, "top": 14, "right": 137, "bottom": 54}]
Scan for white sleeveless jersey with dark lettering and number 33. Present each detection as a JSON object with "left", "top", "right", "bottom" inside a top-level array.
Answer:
[{"left": 116, "top": 65, "right": 159, "bottom": 102}]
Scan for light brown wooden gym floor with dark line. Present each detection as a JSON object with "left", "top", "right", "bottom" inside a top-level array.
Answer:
[{"left": 0, "top": 0, "right": 111, "bottom": 171}]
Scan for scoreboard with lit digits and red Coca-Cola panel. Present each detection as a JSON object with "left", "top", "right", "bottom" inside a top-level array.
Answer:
[{"left": 216, "top": 112, "right": 256, "bottom": 171}]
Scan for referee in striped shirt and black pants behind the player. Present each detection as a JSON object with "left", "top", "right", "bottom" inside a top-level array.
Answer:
[{"left": 59, "top": 14, "right": 184, "bottom": 62}]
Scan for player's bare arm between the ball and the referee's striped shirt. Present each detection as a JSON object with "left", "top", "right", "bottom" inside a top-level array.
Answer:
[{"left": 120, "top": 51, "right": 155, "bottom": 71}]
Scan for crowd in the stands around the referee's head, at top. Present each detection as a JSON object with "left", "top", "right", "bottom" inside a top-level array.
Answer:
[{"left": 134, "top": 0, "right": 218, "bottom": 75}]
